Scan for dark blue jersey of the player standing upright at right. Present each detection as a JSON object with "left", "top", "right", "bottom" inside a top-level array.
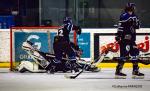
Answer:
[{"left": 117, "top": 12, "right": 140, "bottom": 41}]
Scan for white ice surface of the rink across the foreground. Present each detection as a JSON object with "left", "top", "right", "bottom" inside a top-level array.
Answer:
[{"left": 0, "top": 68, "right": 150, "bottom": 91}]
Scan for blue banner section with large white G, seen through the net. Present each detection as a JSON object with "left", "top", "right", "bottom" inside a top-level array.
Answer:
[{"left": 14, "top": 32, "right": 48, "bottom": 61}]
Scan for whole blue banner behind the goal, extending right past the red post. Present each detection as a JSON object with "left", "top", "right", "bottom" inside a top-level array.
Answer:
[{"left": 14, "top": 32, "right": 90, "bottom": 61}]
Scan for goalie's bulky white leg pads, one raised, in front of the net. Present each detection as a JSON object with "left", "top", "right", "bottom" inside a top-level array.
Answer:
[{"left": 17, "top": 41, "right": 49, "bottom": 73}]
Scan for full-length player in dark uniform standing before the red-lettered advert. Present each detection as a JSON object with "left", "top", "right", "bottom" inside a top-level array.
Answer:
[{"left": 115, "top": 3, "right": 144, "bottom": 77}]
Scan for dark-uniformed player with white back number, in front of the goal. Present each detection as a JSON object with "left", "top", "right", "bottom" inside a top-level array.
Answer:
[{"left": 53, "top": 17, "right": 81, "bottom": 72}]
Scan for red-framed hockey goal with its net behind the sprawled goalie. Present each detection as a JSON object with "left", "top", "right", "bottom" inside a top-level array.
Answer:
[{"left": 10, "top": 27, "right": 76, "bottom": 71}]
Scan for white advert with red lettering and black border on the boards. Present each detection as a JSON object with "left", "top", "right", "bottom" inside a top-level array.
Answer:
[{"left": 94, "top": 33, "right": 150, "bottom": 62}]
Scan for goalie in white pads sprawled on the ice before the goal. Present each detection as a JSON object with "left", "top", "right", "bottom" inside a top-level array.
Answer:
[{"left": 17, "top": 41, "right": 100, "bottom": 73}]
